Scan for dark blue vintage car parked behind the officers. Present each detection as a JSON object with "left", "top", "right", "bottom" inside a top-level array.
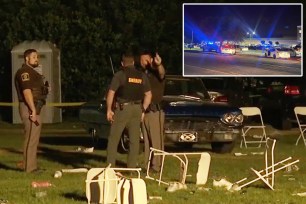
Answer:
[{"left": 80, "top": 75, "right": 243, "bottom": 153}]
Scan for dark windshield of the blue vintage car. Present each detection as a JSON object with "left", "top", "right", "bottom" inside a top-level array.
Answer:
[{"left": 164, "top": 78, "right": 210, "bottom": 100}]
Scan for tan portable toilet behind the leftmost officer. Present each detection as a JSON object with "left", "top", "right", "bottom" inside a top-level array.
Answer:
[{"left": 11, "top": 40, "right": 62, "bottom": 124}]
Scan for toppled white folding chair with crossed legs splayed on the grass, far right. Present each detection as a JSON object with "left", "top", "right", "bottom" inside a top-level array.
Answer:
[{"left": 232, "top": 138, "right": 299, "bottom": 190}]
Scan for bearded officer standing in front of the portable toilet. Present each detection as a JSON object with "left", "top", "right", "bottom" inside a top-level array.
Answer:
[{"left": 15, "top": 49, "right": 48, "bottom": 173}]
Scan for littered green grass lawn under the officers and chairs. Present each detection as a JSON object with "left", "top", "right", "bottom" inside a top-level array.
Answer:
[{"left": 0, "top": 120, "right": 306, "bottom": 204}]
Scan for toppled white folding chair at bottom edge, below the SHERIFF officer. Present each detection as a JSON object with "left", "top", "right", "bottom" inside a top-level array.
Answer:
[{"left": 85, "top": 166, "right": 147, "bottom": 204}]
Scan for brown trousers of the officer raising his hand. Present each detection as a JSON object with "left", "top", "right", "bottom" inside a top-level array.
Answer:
[{"left": 142, "top": 110, "right": 165, "bottom": 171}]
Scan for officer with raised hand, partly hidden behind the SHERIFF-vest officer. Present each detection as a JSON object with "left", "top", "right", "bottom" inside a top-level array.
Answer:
[{"left": 140, "top": 49, "right": 165, "bottom": 172}]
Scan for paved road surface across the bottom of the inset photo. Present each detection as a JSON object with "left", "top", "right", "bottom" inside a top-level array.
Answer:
[{"left": 183, "top": 52, "right": 302, "bottom": 76}]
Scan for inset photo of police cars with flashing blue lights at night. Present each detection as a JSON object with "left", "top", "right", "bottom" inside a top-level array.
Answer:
[{"left": 182, "top": 3, "right": 303, "bottom": 77}]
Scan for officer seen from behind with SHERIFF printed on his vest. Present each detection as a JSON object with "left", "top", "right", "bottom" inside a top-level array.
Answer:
[{"left": 106, "top": 53, "right": 152, "bottom": 168}]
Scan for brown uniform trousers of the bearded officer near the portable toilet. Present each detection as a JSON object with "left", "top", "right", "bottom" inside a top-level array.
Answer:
[{"left": 19, "top": 103, "right": 42, "bottom": 172}]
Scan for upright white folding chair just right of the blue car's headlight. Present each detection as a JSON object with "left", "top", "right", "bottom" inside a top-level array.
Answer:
[{"left": 240, "top": 107, "right": 267, "bottom": 148}]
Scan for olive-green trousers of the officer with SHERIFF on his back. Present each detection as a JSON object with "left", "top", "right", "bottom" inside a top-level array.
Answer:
[{"left": 107, "top": 104, "right": 142, "bottom": 168}]
